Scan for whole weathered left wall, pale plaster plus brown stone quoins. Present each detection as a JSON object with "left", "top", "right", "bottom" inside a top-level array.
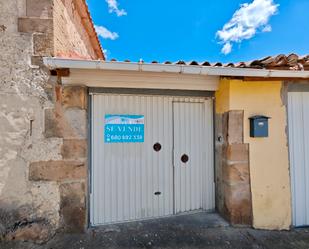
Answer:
[{"left": 0, "top": 0, "right": 92, "bottom": 242}]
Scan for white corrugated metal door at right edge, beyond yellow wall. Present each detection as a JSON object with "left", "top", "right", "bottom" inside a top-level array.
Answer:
[{"left": 288, "top": 92, "right": 309, "bottom": 226}]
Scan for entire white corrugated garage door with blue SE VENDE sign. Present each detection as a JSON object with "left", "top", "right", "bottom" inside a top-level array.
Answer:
[{"left": 90, "top": 94, "right": 215, "bottom": 225}]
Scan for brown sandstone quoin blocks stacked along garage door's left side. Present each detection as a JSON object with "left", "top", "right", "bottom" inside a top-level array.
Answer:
[{"left": 29, "top": 85, "right": 87, "bottom": 232}]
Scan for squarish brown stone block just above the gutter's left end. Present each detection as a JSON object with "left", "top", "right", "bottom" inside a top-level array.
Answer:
[{"left": 33, "top": 34, "right": 54, "bottom": 56}]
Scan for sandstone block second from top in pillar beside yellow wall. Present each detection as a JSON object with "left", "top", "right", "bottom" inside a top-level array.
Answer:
[{"left": 226, "top": 144, "right": 249, "bottom": 164}]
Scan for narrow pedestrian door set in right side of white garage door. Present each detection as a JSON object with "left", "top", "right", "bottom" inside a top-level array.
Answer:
[{"left": 173, "top": 100, "right": 215, "bottom": 213}]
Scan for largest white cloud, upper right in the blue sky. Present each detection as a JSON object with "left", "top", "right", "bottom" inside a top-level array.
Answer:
[{"left": 216, "top": 0, "right": 279, "bottom": 54}]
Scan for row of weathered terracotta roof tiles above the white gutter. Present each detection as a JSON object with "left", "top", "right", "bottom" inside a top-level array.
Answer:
[{"left": 111, "top": 54, "right": 309, "bottom": 71}]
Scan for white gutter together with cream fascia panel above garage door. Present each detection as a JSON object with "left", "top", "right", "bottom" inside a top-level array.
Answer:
[{"left": 44, "top": 58, "right": 309, "bottom": 91}]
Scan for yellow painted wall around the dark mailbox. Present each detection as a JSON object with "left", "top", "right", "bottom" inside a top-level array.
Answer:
[{"left": 216, "top": 79, "right": 291, "bottom": 229}]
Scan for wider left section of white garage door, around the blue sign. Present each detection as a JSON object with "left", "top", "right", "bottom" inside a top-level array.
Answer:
[{"left": 91, "top": 94, "right": 173, "bottom": 225}]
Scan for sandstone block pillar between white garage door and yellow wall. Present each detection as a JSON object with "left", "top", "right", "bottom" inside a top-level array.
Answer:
[{"left": 216, "top": 110, "right": 252, "bottom": 225}]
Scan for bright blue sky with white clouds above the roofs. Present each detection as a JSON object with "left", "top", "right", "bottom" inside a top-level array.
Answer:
[{"left": 87, "top": 0, "right": 309, "bottom": 62}]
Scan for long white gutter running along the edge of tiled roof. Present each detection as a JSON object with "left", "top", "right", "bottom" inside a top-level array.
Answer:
[{"left": 43, "top": 57, "right": 309, "bottom": 79}]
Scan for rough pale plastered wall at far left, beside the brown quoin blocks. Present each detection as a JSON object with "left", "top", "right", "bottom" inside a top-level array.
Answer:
[{"left": 0, "top": 0, "right": 62, "bottom": 241}]
